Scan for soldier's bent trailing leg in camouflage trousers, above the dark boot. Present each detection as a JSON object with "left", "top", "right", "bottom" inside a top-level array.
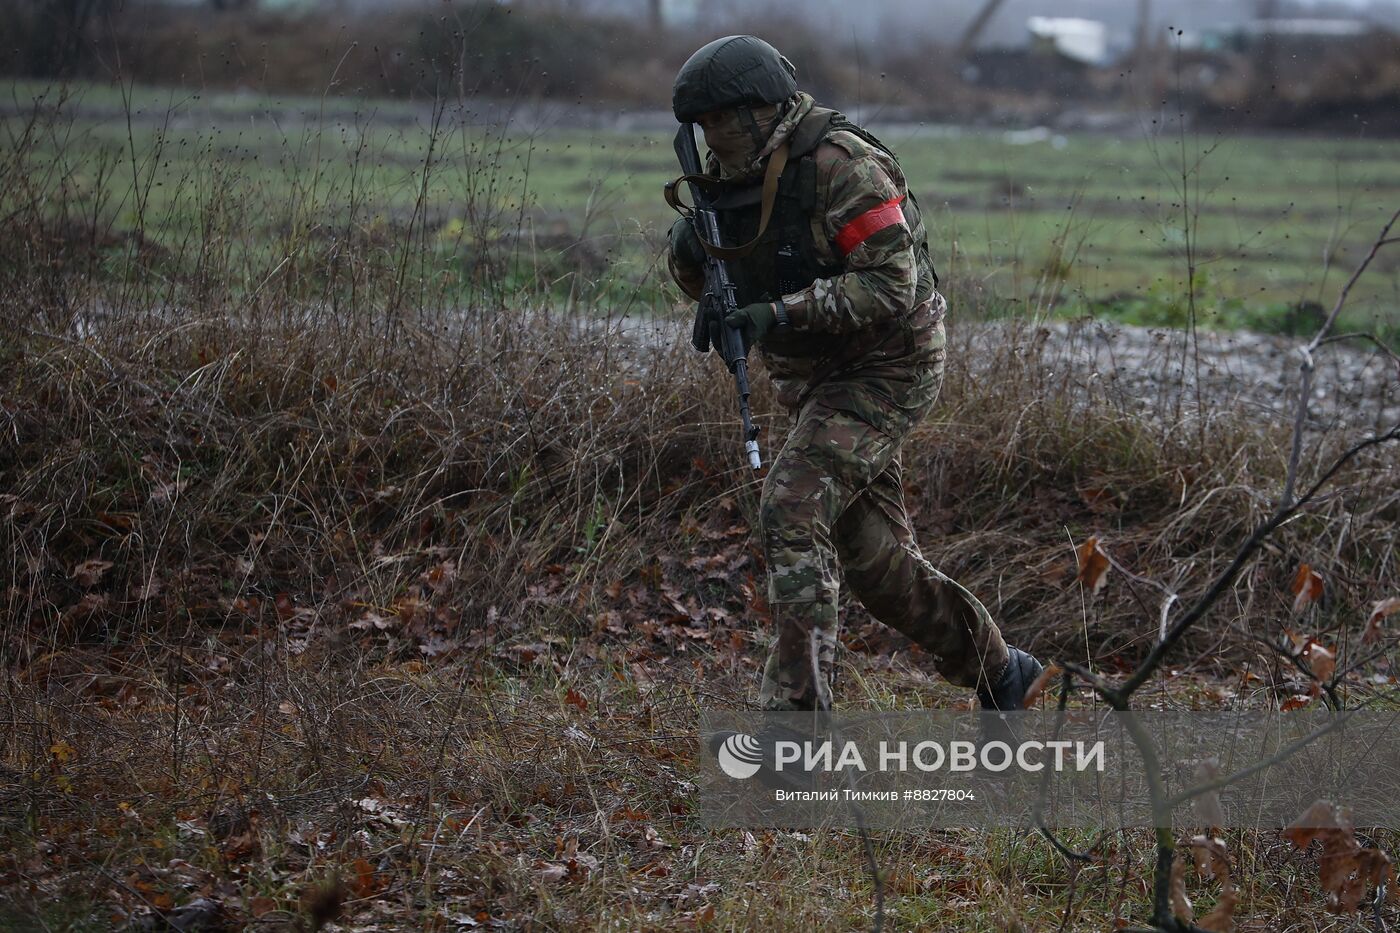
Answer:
[{"left": 836, "top": 457, "right": 1008, "bottom": 688}]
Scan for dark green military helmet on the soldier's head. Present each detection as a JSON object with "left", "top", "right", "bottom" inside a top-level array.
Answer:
[{"left": 671, "top": 35, "right": 797, "bottom": 123}]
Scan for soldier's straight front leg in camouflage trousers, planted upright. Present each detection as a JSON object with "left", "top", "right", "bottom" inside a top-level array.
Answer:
[{"left": 759, "top": 402, "right": 896, "bottom": 709}]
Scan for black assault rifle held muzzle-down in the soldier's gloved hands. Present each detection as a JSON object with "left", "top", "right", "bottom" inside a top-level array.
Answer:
[{"left": 666, "top": 123, "right": 763, "bottom": 469}]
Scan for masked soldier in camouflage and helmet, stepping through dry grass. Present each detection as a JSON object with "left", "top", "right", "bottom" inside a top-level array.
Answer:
[{"left": 669, "top": 35, "right": 1042, "bottom": 710}]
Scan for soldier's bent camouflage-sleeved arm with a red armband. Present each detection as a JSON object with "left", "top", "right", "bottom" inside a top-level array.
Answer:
[{"left": 783, "top": 143, "right": 918, "bottom": 333}]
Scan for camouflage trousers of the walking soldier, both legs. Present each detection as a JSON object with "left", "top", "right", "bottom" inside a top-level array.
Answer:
[{"left": 760, "top": 313, "right": 1007, "bottom": 709}]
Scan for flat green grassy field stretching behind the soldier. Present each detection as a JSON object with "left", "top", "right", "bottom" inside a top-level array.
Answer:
[{"left": 3, "top": 83, "right": 1400, "bottom": 329}]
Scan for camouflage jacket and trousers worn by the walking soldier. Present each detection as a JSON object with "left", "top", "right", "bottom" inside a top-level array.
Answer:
[{"left": 671, "top": 94, "right": 1008, "bottom": 709}]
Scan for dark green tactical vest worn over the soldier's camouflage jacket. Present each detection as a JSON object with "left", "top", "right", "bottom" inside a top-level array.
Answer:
[{"left": 714, "top": 108, "right": 938, "bottom": 356}]
